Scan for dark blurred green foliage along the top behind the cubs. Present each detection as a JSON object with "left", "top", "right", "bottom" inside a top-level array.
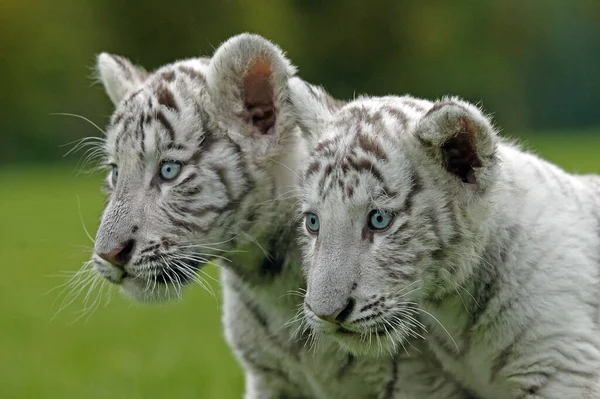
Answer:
[{"left": 0, "top": 0, "right": 600, "bottom": 165}]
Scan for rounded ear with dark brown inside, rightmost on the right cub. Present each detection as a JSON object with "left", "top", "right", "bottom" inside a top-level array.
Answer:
[{"left": 415, "top": 98, "right": 497, "bottom": 186}]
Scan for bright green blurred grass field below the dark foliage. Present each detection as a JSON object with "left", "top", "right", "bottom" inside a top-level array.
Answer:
[{"left": 0, "top": 133, "right": 600, "bottom": 399}]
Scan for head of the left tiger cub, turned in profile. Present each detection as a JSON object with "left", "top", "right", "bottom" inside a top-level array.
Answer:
[{"left": 92, "top": 34, "right": 306, "bottom": 301}]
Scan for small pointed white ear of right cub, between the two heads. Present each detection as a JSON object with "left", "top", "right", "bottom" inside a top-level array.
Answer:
[{"left": 290, "top": 78, "right": 345, "bottom": 143}]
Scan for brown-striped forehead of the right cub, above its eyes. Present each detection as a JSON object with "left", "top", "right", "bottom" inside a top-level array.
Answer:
[{"left": 304, "top": 97, "right": 428, "bottom": 202}]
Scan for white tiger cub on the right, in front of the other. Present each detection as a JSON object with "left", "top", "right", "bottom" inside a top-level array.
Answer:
[{"left": 299, "top": 97, "right": 600, "bottom": 399}]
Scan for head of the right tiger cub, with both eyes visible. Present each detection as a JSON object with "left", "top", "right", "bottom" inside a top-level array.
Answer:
[{"left": 292, "top": 96, "right": 499, "bottom": 354}]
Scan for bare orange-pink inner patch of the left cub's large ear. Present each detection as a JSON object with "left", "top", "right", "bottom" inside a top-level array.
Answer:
[{"left": 243, "top": 58, "right": 275, "bottom": 134}]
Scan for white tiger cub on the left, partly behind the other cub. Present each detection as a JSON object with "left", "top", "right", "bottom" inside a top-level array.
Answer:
[{"left": 88, "top": 34, "right": 466, "bottom": 399}]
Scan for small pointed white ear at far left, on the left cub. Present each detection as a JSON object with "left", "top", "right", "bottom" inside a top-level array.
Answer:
[{"left": 96, "top": 53, "right": 148, "bottom": 105}]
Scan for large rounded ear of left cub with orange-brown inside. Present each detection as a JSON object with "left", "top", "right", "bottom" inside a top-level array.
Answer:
[{"left": 207, "top": 33, "right": 296, "bottom": 154}]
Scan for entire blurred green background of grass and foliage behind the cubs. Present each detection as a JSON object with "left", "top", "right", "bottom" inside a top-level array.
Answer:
[{"left": 0, "top": 0, "right": 600, "bottom": 398}]
